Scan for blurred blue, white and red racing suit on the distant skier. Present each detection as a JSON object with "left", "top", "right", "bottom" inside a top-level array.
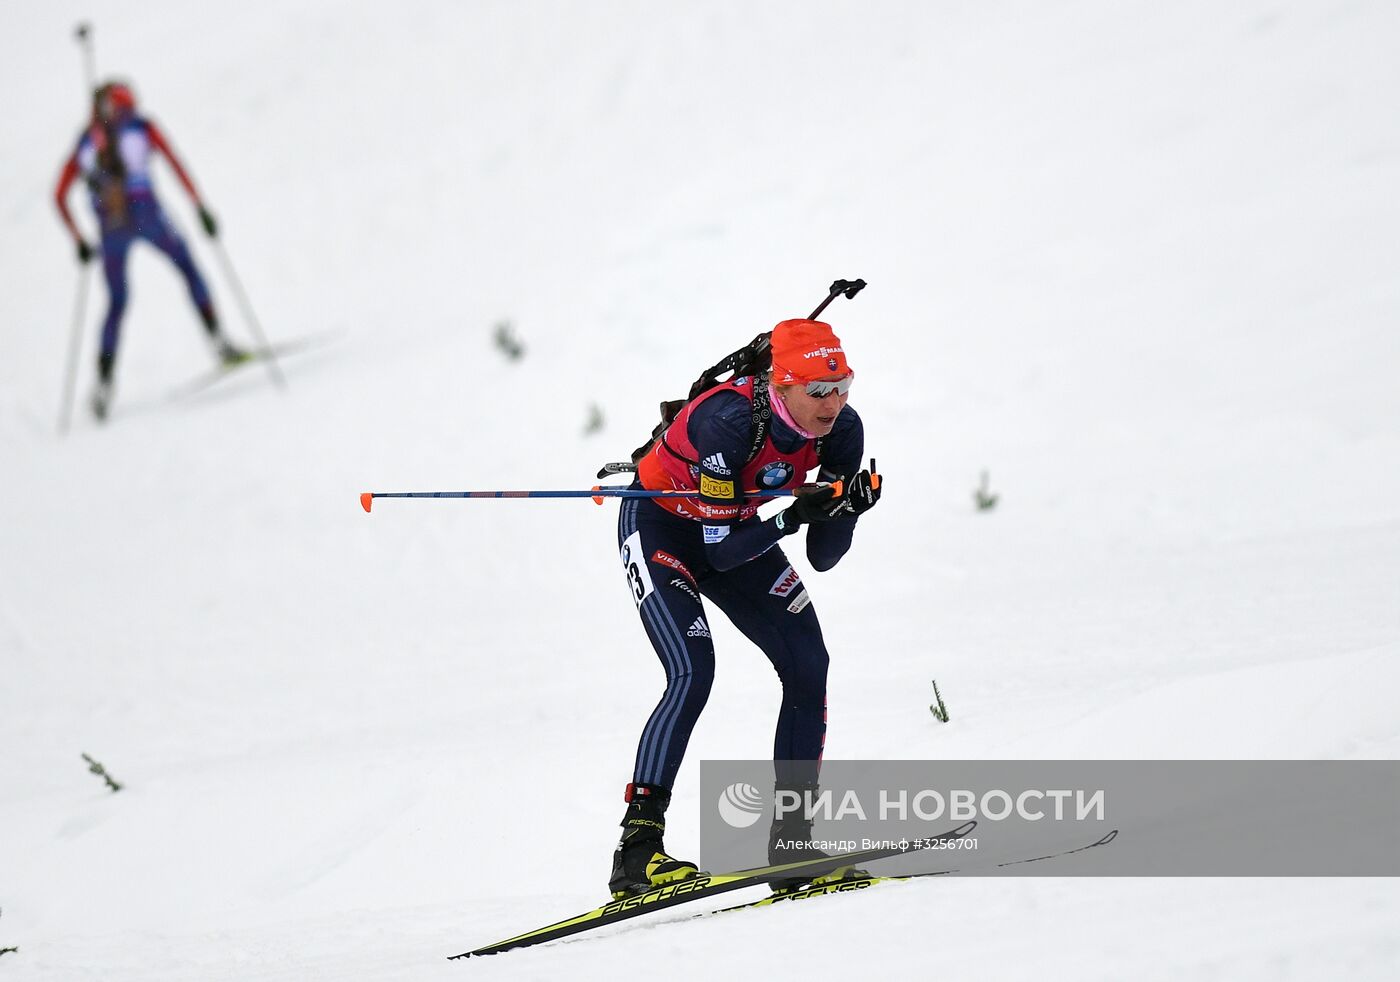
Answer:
[{"left": 53, "top": 115, "right": 214, "bottom": 357}]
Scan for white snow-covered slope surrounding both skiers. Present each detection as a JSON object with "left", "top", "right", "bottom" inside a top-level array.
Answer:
[{"left": 0, "top": 0, "right": 1400, "bottom": 982}]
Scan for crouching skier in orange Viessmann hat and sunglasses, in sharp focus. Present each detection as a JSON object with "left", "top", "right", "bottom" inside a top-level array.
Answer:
[{"left": 609, "top": 319, "right": 881, "bottom": 898}]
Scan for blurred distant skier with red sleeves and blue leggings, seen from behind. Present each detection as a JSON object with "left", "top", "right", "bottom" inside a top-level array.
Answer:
[{"left": 53, "top": 81, "right": 249, "bottom": 419}]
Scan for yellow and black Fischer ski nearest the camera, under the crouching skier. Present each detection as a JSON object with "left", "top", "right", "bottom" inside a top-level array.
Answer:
[{"left": 451, "top": 821, "right": 977, "bottom": 958}]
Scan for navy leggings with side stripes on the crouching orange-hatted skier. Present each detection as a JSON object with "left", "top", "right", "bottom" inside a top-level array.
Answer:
[{"left": 617, "top": 499, "right": 827, "bottom": 787}]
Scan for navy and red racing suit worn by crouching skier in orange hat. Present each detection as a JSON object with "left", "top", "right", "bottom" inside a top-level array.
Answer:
[{"left": 617, "top": 378, "right": 864, "bottom": 787}]
